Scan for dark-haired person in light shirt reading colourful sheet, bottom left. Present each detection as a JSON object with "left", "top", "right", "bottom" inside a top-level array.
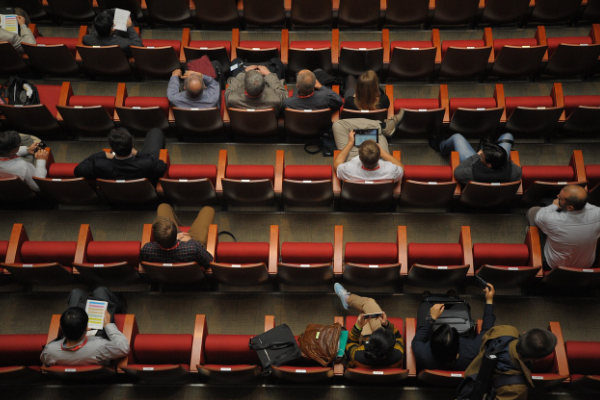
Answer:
[{"left": 40, "top": 287, "right": 129, "bottom": 367}]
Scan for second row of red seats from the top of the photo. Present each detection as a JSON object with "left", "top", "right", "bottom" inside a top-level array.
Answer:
[{"left": 0, "top": 24, "right": 600, "bottom": 80}]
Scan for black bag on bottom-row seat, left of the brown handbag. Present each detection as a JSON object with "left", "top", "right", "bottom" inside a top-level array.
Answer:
[{"left": 248, "top": 324, "right": 302, "bottom": 376}]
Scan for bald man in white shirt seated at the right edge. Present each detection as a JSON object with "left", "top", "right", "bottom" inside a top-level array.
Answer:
[{"left": 527, "top": 185, "right": 600, "bottom": 269}]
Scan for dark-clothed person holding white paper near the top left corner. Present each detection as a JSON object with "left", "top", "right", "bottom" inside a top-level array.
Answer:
[{"left": 83, "top": 8, "right": 144, "bottom": 57}]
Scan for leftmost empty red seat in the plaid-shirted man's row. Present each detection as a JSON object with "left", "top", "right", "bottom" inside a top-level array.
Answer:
[{"left": 1, "top": 224, "right": 77, "bottom": 286}]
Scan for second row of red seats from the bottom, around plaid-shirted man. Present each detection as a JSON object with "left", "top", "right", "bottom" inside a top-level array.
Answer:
[{"left": 0, "top": 219, "right": 600, "bottom": 293}]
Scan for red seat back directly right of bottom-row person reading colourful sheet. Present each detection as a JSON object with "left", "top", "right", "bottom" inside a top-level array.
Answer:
[{"left": 131, "top": 334, "right": 193, "bottom": 365}]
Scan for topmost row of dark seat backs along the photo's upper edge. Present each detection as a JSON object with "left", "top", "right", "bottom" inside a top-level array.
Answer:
[{"left": 13, "top": 0, "right": 600, "bottom": 29}]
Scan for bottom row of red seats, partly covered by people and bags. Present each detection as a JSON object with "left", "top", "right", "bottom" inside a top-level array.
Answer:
[{"left": 0, "top": 314, "right": 584, "bottom": 391}]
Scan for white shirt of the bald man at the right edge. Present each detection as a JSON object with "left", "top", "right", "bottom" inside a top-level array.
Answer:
[{"left": 535, "top": 203, "right": 600, "bottom": 268}]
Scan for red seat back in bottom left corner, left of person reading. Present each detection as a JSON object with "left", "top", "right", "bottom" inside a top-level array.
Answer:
[{"left": 0, "top": 333, "right": 48, "bottom": 367}]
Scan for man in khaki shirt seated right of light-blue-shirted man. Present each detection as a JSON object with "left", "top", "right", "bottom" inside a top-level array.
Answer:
[{"left": 225, "top": 65, "right": 288, "bottom": 115}]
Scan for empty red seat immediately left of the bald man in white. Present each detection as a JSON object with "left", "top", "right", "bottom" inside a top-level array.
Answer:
[{"left": 473, "top": 227, "right": 543, "bottom": 288}]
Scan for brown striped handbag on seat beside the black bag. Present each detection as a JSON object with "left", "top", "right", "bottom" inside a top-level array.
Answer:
[{"left": 298, "top": 323, "right": 342, "bottom": 367}]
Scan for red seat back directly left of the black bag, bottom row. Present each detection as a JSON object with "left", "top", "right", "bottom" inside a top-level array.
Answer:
[{"left": 200, "top": 334, "right": 260, "bottom": 365}]
